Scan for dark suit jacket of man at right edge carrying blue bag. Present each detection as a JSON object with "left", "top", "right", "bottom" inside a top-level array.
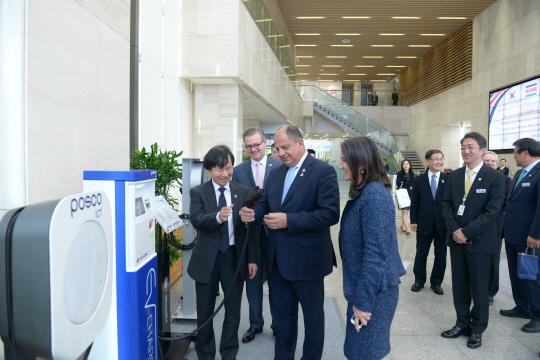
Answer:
[{"left": 504, "top": 163, "right": 540, "bottom": 245}]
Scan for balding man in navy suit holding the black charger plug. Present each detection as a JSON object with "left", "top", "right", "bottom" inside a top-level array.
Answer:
[{"left": 242, "top": 125, "right": 340, "bottom": 360}]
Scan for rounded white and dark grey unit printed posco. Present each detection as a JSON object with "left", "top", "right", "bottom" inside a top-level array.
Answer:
[{"left": 0, "top": 191, "right": 113, "bottom": 360}]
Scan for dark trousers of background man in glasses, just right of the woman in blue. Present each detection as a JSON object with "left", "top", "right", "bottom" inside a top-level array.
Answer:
[{"left": 413, "top": 222, "right": 447, "bottom": 286}]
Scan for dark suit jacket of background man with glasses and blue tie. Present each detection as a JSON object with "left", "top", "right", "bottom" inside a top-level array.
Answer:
[{"left": 411, "top": 172, "right": 448, "bottom": 236}]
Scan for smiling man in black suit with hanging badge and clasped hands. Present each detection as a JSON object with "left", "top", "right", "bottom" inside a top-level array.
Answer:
[{"left": 441, "top": 132, "right": 504, "bottom": 349}]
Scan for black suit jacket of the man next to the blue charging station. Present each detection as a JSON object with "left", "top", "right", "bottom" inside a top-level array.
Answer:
[{"left": 187, "top": 181, "right": 259, "bottom": 284}]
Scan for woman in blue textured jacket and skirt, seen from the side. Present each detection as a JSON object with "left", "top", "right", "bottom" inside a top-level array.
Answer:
[{"left": 339, "top": 136, "right": 405, "bottom": 360}]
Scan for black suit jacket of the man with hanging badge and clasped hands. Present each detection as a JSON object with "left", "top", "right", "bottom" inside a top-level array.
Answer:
[{"left": 442, "top": 164, "right": 504, "bottom": 254}]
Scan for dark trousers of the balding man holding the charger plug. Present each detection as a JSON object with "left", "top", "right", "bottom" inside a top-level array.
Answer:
[{"left": 268, "top": 262, "right": 324, "bottom": 360}]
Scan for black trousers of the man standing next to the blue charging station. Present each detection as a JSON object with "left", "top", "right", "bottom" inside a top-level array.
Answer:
[{"left": 195, "top": 246, "right": 244, "bottom": 360}]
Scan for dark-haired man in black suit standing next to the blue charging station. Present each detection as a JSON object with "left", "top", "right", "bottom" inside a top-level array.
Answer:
[{"left": 187, "top": 145, "right": 259, "bottom": 360}]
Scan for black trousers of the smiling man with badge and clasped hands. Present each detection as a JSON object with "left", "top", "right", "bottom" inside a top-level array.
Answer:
[{"left": 450, "top": 245, "right": 493, "bottom": 334}]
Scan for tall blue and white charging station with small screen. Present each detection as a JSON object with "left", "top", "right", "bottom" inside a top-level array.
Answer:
[{"left": 83, "top": 170, "right": 159, "bottom": 360}]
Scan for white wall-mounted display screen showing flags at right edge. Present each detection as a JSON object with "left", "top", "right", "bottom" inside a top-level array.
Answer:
[{"left": 488, "top": 77, "right": 540, "bottom": 150}]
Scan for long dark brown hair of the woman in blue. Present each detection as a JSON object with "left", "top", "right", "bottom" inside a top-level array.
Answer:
[{"left": 341, "top": 136, "right": 392, "bottom": 197}]
